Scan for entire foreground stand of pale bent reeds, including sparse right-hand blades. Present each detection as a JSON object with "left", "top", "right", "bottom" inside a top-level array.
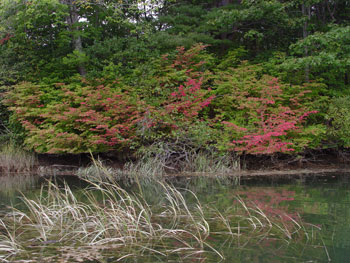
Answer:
[{"left": 0, "top": 176, "right": 326, "bottom": 262}]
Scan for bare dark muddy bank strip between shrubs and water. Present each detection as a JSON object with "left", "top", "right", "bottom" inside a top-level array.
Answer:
[{"left": 0, "top": 151, "right": 350, "bottom": 182}]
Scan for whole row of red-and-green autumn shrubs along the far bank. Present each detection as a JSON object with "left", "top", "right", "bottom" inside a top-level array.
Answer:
[{"left": 5, "top": 44, "right": 325, "bottom": 158}]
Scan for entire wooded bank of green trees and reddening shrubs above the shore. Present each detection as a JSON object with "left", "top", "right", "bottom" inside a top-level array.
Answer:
[{"left": 0, "top": 0, "right": 350, "bottom": 158}]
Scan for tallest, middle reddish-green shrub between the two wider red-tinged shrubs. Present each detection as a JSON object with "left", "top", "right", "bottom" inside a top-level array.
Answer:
[{"left": 138, "top": 44, "right": 214, "bottom": 151}]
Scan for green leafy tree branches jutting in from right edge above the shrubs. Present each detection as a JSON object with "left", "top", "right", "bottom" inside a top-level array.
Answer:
[{"left": 281, "top": 25, "right": 350, "bottom": 94}]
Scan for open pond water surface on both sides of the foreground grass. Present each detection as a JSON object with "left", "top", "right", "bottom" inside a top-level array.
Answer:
[{"left": 0, "top": 175, "right": 350, "bottom": 262}]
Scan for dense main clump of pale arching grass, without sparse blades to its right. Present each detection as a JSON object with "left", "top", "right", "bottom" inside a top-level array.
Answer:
[{"left": 0, "top": 179, "right": 222, "bottom": 262}]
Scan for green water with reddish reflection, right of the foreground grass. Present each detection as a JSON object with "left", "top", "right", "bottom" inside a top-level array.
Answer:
[{"left": 172, "top": 176, "right": 350, "bottom": 262}]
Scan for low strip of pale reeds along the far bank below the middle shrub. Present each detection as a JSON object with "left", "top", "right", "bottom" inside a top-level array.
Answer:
[{"left": 77, "top": 153, "right": 240, "bottom": 186}]
